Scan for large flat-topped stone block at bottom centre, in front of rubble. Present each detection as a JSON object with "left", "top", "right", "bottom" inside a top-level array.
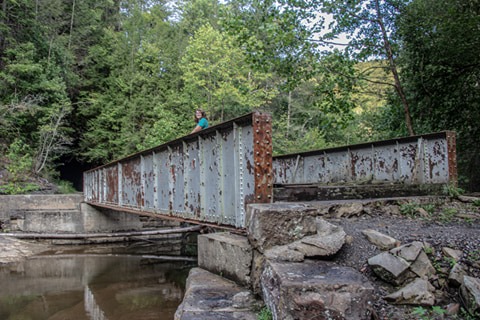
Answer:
[{"left": 261, "top": 260, "right": 374, "bottom": 320}]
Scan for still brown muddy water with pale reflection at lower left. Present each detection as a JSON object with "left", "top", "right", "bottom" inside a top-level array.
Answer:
[{"left": 0, "top": 247, "right": 196, "bottom": 320}]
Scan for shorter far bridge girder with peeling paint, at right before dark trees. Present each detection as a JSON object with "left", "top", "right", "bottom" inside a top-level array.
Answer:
[{"left": 273, "top": 131, "right": 457, "bottom": 185}]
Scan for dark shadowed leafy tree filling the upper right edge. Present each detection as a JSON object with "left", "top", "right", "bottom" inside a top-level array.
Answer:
[{"left": 399, "top": 0, "right": 480, "bottom": 190}]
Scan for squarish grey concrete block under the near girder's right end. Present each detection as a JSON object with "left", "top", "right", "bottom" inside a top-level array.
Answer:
[{"left": 198, "top": 232, "right": 252, "bottom": 286}]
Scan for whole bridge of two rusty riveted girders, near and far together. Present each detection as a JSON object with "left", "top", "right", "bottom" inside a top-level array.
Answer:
[{"left": 83, "top": 112, "right": 457, "bottom": 229}]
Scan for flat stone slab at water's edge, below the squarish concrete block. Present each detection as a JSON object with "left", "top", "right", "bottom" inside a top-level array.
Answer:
[{"left": 175, "top": 268, "right": 260, "bottom": 320}]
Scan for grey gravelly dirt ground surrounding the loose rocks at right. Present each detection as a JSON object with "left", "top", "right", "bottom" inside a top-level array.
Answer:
[{"left": 331, "top": 200, "right": 480, "bottom": 320}]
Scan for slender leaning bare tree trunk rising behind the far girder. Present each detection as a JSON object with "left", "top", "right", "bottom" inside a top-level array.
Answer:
[{"left": 375, "top": 0, "right": 415, "bottom": 136}]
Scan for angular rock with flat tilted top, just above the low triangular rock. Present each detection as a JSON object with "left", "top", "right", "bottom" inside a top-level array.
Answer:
[{"left": 368, "top": 252, "right": 414, "bottom": 285}]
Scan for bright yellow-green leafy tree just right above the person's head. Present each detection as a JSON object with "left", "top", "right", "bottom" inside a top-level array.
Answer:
[{"left": 181, "top": 25, "right": 275, "bottom": 121}]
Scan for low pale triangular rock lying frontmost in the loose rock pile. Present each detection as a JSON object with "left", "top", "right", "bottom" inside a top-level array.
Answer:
[{"left": 385, "top": 278, "right": 435, "bottom": 306}]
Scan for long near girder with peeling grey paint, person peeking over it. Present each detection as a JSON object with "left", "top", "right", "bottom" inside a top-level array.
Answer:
[{"left": 83, "top": 112, "right": 273, "bottom": 228}]
